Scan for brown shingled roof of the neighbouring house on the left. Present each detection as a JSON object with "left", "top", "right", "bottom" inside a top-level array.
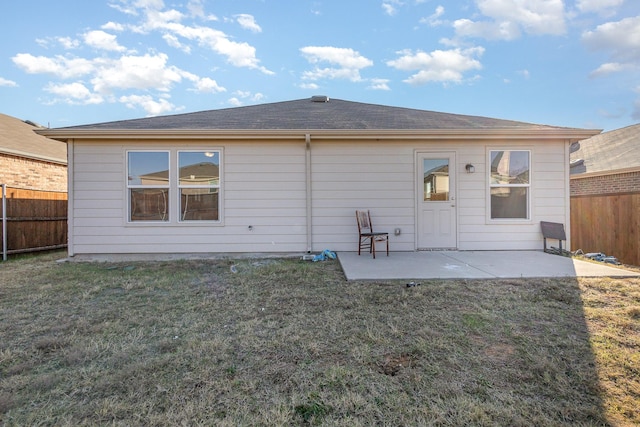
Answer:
[{"left": 0, "top": 114, "right": 67, "bottom": 165}]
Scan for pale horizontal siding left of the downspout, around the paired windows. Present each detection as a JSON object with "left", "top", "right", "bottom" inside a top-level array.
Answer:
[{"left": 72, "top": 141, "right": 306, "bottom": 254}]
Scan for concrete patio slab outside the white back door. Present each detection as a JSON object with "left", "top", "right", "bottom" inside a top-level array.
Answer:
[{"left": 338, "top": 251, "right": 640, "bottom": 280}]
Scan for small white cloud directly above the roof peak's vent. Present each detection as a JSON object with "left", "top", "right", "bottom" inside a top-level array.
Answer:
[{"left": 300, "top": 46, "right": 373, "bottom": 82}]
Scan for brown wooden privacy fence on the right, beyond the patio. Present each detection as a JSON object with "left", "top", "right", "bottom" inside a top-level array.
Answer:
[{"left": 571, "top": 192, "right": 640, "bottom": 265}]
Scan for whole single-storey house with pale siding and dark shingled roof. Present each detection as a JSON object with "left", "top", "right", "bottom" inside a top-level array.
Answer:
[{"left": 38, "top": 96, "right": 599, "bottom": 256}]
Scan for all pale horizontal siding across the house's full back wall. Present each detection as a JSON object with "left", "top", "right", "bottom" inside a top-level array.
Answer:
[{"left": 70, "top": 136, "right": 569, "bottom": 254}]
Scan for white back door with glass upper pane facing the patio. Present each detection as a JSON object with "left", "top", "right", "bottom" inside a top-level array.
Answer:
[{"left": 416, "top": 152, "right": 458, "bottom": 249}]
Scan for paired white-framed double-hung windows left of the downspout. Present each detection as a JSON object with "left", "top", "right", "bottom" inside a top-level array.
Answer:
[{"left": 127, "top": 150, "right": 221, "bottom": 223}]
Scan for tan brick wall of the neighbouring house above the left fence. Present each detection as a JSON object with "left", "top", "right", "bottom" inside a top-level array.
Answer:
[{"left": 0, "top": 154, "right": 67, "bottom": 192}]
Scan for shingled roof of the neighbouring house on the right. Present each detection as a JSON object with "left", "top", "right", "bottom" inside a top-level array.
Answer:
[{"left": 571, "top": 124, "right": 640, "bottom": 175}]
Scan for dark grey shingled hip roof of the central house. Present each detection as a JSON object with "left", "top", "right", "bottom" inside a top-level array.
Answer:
[{"left": 41, "top": 97, "right": 599, "bottom": 139}]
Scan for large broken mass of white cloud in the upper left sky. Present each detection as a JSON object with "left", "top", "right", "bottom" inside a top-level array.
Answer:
[{"left": 13, "top": 0, "right": 274, "bottom": 115}]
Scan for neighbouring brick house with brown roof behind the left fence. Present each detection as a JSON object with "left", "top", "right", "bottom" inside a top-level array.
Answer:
[{"left": 0, "top": 114, "right": 67, "bottom": 192}]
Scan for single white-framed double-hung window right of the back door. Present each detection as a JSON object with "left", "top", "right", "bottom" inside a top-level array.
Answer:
[{"left": 489, "top": 150, "right": 531, "bottom": 220}]
